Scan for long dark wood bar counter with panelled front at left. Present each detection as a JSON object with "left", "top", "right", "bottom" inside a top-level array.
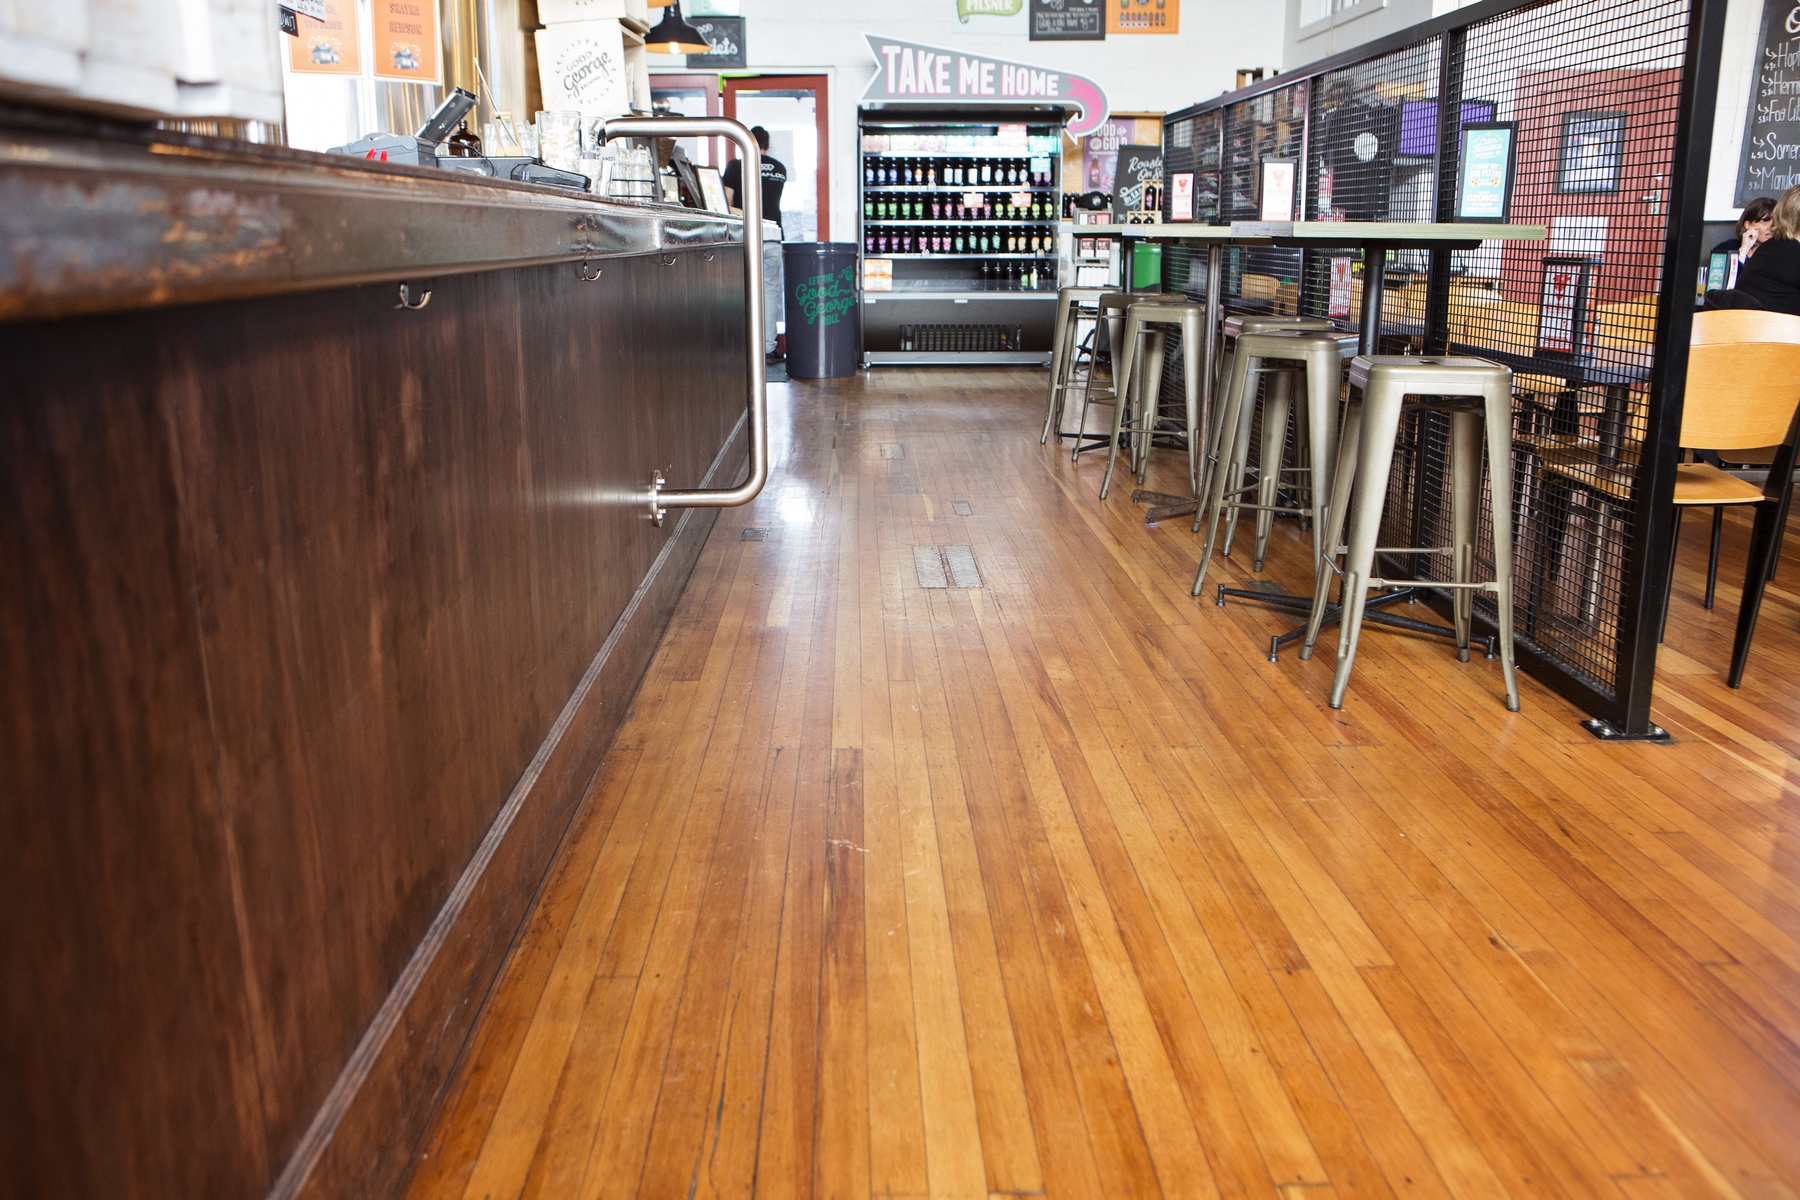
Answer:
[{"left": 0, "top": 110, "right": 745, "bottom": 1198}]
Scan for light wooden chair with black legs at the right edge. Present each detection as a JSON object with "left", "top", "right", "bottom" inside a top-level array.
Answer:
[{"left": 1665, "top": 309, "right": 1800, "bottom": 687}]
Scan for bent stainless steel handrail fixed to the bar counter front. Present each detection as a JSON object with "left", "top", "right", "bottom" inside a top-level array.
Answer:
[{"left": 599, "top": 117, "right": 769, "bottom": 525}]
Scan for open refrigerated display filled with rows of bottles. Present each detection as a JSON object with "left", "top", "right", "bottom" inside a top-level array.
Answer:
[{"left": 857, "top": 106, "right": 1064, "bottom": 365}]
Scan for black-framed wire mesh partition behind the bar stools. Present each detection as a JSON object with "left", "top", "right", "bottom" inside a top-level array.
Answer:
[{"left": 1163, "top": 0, "right": 1724, "bottom": 736}]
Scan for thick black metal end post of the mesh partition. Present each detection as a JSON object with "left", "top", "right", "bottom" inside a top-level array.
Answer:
[{"left": 1582, "top": 0, "right": 1726, "bottom": 739}]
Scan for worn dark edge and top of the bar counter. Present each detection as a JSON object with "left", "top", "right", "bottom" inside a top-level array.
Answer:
[{"left": 0, "top": 108, "right": 743, "bottom": 320}]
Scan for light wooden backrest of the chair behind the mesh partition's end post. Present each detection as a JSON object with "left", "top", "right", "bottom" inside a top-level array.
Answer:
[{"left": 1681, "top": 309, "right": 1800, "bottom": 450}]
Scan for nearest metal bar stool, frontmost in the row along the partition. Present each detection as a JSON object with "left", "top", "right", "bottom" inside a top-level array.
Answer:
[{"left": 1300, "top": 354, "right": 1519, "bottom": 712}]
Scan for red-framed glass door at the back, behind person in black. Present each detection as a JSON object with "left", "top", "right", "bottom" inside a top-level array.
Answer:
[{"left": 724, "top": 76, "right": 832, "bottom": 241}]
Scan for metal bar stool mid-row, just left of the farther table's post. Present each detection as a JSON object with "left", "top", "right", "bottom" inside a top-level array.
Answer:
[{"left": 1100, "top": 295, "right": 1206, "bottom": 500}]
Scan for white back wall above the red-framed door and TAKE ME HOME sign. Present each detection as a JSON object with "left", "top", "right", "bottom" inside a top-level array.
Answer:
[{"left": 650, "top": 0, "right": 1282, "bottom": 241}]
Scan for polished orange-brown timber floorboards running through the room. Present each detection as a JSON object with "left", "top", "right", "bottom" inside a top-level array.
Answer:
[{"left": 409, "top": 369, "right": 1800, "bottom": 1200}]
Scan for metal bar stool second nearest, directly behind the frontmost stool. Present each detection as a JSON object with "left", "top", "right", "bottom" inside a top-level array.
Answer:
[{"left": 1193, "top": 329, "right": 1357, "bottom": 596}]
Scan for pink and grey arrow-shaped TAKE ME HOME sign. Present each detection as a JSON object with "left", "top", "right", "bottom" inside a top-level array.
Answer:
[{"left": 862, "top": 34, "right": 1107, "bottom": 137}]
